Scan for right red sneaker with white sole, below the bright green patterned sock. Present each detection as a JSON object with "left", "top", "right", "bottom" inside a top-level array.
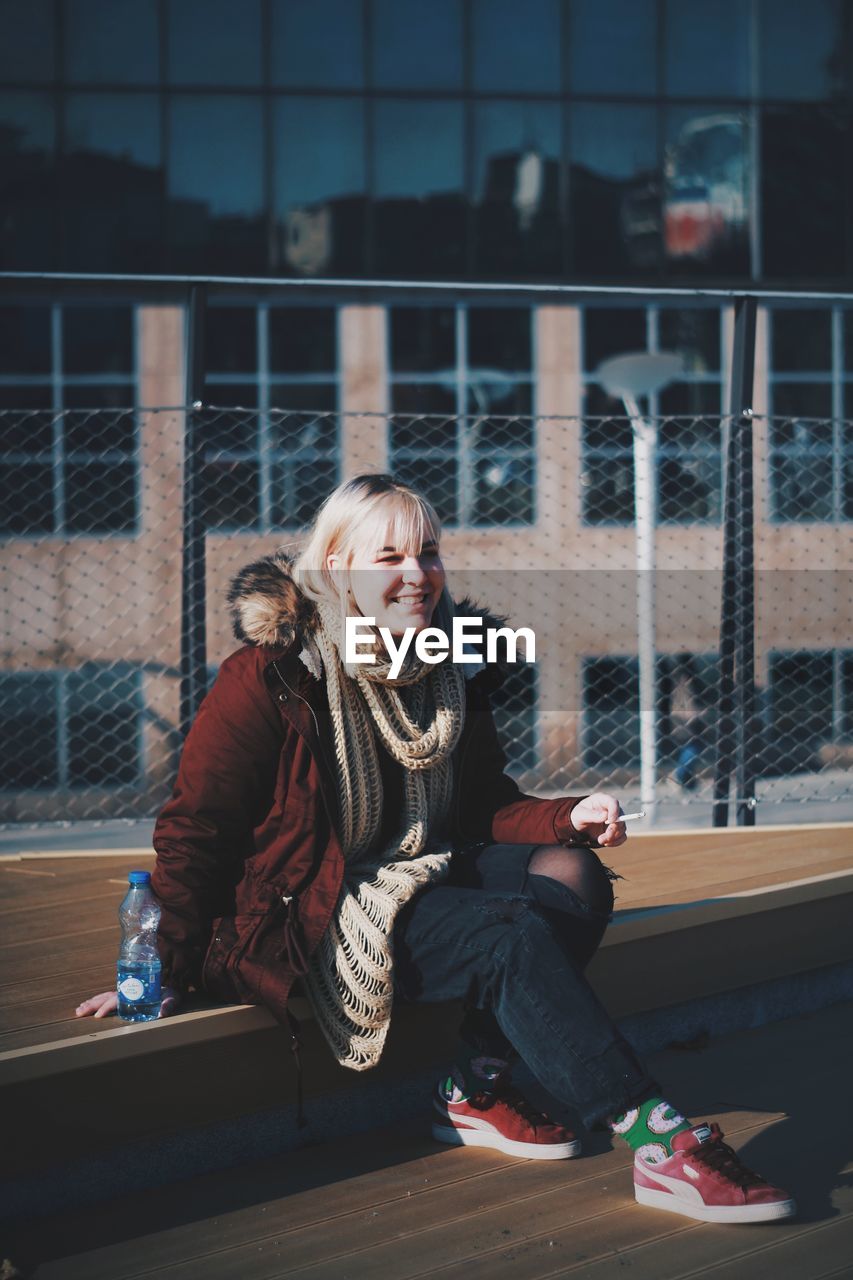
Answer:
[{"left": 634, "top": 1124, "right": 797, "bottom": 1222}]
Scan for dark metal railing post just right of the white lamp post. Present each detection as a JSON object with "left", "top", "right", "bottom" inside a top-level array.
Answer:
[{"left": 713, "top": 297, "right": 757, "bottom": 827}]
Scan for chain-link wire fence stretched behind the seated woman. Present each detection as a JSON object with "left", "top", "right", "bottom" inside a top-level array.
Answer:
[{"left": 0, "top": 396, "right": 853, "bottom": 823}]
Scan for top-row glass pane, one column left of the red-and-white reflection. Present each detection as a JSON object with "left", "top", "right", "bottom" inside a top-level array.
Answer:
[{"left": 569, "top": 0, "right": 657, "bottom": 93}]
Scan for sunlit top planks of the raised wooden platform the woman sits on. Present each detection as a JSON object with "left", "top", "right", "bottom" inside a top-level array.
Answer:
[{"left": 0, "top": 823, "right": 853, "bottom": 1055}]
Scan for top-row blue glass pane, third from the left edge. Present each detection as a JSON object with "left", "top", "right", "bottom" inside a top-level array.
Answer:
[{"left": 169, "top": 0, "right": 261, "bottom": 86}]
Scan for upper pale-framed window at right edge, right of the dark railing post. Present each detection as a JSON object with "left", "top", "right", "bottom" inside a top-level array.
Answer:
[{"left": 770, "top": 307, "right": 853, "bottom": 522}]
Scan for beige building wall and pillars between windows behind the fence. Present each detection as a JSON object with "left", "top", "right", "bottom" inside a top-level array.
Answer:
[{"left": 0, "top": 305, "right": 853, "bottom": 818}]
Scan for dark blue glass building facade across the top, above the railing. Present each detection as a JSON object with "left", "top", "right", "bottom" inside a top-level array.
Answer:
[{"left": 0, "top": 0, "right": 853, "bottom": 284}]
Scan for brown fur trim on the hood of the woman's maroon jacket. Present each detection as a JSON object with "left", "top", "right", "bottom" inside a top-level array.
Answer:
[{"left": 222, "top": 552, "right": 507, "bottom": 675}]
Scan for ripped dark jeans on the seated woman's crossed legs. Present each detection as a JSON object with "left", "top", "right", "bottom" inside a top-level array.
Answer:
[{"left": 393, "top": 845, "right": 660, "bottom": 1125}]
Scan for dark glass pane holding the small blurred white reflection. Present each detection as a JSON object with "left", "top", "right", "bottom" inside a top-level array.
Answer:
[{"left": 474, "top": 101, "right": 562, "bottom": 275}]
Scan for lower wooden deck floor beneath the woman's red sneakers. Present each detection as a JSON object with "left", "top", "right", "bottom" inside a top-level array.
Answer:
[{"left": 3, "top": 1005, "right": 853, "bottom": 1280}]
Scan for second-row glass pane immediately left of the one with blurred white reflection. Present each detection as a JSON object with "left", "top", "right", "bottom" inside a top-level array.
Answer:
[{"left": 374, "top": 99, "right": 465, "bottom": 278}]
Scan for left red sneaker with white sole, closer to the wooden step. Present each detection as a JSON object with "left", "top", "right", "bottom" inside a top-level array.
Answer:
[{"left": 433, "top": 1084, "right": 580, "bottom": 1160}]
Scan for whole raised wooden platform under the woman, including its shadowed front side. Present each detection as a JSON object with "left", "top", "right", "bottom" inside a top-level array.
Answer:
[{"left": 0, "top": 823, "right": 853, "bottom": 1203}]
